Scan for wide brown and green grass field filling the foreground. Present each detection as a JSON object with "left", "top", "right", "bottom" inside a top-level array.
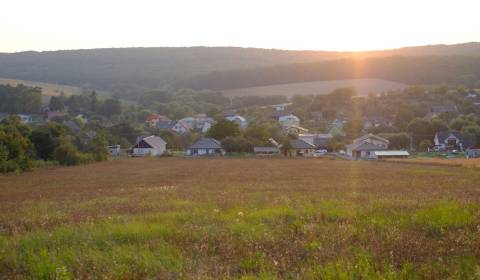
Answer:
[{"left": 0, "top": 158, "right": 480, "bottom": 279}]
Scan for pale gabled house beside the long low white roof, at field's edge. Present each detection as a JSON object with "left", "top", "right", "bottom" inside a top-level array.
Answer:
[{"left": 347, "top": 134, "right": 389, "bottom": 159}]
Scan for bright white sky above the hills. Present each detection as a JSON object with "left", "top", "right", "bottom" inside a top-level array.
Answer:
[{"left": 0, "top": 0, "right": 480, "bottom": 52}]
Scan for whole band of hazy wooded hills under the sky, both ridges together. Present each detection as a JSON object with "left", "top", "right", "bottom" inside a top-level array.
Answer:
[{"left": 0, "top": 43, "right": 480, "bottom": 98}]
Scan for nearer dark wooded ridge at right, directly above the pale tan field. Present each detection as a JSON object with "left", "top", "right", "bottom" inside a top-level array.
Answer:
[{"left": 182, "top": 56, "right": 480, "bottom": 90}]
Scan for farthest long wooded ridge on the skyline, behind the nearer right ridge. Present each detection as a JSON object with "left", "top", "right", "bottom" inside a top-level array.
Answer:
[{"left": 0, "top": 43, "right": 480, "bottom": 97}]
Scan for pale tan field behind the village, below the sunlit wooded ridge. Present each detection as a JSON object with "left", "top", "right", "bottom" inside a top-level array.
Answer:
[{"left": 223, "top": 79, "right": 407, "bottom": 97}]
